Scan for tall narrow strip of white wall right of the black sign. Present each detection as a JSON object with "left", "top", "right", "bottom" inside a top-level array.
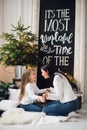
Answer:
[{"left": 74, "top": 0, "right": 86, "bottom": 101}]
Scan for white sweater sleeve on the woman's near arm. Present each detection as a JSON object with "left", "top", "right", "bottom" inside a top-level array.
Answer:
[{"left": 47, "top": 75, "right": 63, "bottom": 101}]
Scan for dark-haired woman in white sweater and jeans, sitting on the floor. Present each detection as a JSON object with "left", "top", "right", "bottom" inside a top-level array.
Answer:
[{"left": 41, "top": 65, "right": 79, "bottom": 116}]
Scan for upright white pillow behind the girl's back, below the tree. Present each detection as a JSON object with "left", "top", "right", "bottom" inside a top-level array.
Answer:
[{"left": 9, "top": 88, "right": 20, "bottom": 100}]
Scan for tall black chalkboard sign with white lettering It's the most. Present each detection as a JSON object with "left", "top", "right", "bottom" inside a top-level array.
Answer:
[{"left": 37, "top": 0, "right": 75, "bottom": 88}]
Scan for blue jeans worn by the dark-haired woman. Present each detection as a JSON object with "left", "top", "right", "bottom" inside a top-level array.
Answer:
[{"left": 42, "top": 99, "right": 79, "bottom": 116}]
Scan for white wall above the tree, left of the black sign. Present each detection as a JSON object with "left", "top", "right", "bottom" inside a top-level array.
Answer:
[{"left": 0, "top": 0, "right": 39, "bottom": 33}]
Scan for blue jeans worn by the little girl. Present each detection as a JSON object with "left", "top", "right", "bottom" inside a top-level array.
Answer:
[{"left": 20, "top": 103, "right": 42, "bottom": 112}]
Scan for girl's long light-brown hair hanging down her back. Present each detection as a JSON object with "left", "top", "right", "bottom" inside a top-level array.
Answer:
[{"left": 19, "top": 68, "right": 35, "bottom": 101}]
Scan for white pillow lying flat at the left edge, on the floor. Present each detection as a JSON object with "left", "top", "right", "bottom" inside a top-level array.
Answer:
[{"left": 0, "top": 100, "right": 19, "bottom": 111}]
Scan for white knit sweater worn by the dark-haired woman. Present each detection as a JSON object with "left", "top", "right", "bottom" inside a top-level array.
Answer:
[{"left": 47, "top": 73, "right": 77, "bottom": 103}]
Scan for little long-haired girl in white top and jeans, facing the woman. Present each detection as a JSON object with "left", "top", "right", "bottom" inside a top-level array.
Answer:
[{"left": 19, "top": 68, "right": 46, "bottom": 112}]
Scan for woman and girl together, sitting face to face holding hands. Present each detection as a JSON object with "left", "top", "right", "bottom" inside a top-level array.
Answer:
[{"left": 19, "top": 65, "right": 79, "bottom": 116}]
